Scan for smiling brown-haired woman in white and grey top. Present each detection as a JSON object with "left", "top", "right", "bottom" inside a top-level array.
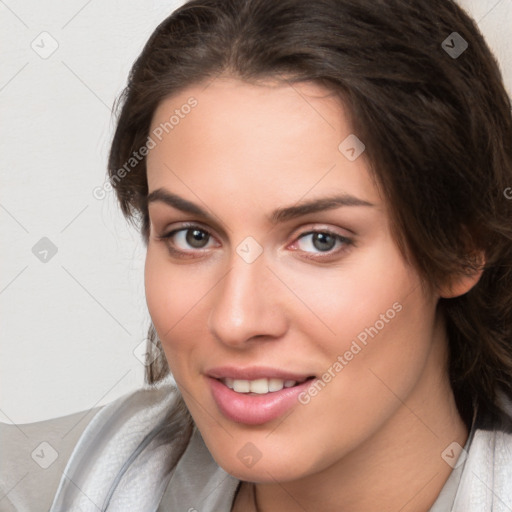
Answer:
[{"left": 2, "top": 0, "right": 512, "bottom": 512}]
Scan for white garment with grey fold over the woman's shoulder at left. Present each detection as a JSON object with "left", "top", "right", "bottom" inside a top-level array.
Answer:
[{"left": 51, "top": 377, "right": 192, "bottom": 512}]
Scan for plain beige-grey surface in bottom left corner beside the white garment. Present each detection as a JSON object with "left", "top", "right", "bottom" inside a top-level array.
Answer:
[{"left": 0, "top": 407, "right": 102, "bottom": 512}]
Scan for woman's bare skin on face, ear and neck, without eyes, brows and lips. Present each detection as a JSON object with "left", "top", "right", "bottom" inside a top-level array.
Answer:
[{"left": 145, "top": 77, "right": 479, "bottom": 512}]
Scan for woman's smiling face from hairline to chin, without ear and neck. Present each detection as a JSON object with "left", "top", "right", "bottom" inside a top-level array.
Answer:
[{"left": 145, "top": 78, "right": 445, "bottom": 482}]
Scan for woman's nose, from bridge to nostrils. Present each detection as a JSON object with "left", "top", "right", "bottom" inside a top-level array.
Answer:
[{"left": 208, "top": 254, "right": 287, "bottom": 348}]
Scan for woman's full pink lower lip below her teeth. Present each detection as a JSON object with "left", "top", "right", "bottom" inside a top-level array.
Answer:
[{"left": 208, "top": 377, "right": 313, "bottom": 425}]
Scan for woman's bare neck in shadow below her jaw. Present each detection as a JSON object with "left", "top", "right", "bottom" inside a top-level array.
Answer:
[{"left": 233, "top": 318, "right": 468, "bottom": 512}]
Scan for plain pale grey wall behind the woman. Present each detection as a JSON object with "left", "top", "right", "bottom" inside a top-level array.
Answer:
[{"left": 0, "top": 0, "right": 512, "bottom": 423}]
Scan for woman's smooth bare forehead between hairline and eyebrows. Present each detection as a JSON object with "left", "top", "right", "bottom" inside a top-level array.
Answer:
[{"left": 147, "top": 78, "right": 380, "bottom": 214}]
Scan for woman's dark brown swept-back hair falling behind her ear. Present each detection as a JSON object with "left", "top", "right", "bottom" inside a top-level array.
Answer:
[{"left": 108, "top": 0, "right": 512, "bottom": 430}]
